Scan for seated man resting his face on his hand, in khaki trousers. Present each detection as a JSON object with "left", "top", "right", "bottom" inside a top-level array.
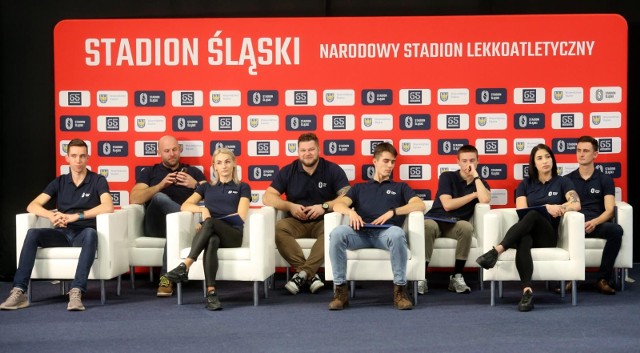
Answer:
[{"left": 418, "top": 145, "right": 491, "bottom": 294}]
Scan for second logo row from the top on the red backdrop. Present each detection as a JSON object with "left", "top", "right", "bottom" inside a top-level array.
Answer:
[{"left": 60, "top": 112, "right": 622, "bottom": 132}]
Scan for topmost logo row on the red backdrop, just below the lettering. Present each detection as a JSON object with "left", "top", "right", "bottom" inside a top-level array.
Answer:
[{"left": 58, "top": 87, "right": 622, "bottom": 107}]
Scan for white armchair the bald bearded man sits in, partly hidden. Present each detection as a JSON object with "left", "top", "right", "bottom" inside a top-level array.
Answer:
[{"left": 122, "top": 204, "right": 167, "bottom": 289}]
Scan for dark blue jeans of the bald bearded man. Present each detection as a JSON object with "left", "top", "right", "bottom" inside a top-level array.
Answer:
[{"left": 144, "top": 192, "right": 180, "bottom": 273}]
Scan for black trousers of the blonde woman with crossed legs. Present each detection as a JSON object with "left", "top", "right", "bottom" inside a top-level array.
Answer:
[{"left": 188, "top": 217, "right": 243, "bottom": 287}]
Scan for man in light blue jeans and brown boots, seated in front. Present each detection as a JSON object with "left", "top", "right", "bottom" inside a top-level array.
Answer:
[{"left": 329, "top": 142, "right": 425, "bottom": 310}]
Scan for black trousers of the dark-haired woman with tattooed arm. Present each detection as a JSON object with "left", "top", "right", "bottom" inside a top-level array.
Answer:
[{"left": 500, "top": 212, "right": 558, "bottom": 288}]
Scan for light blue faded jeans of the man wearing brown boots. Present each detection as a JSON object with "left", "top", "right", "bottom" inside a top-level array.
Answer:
[{"left": 329, "top": 225, "right": 407, "bottom": 286}]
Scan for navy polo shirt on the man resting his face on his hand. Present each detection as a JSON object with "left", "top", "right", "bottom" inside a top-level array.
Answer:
[{"left": 427, "top": 170, "right": 491, "bottom": 221}]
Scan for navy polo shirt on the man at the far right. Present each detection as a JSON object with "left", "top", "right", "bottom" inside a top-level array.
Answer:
[{"left": 567, "top": 169, "right": 616, "bottom": 221}]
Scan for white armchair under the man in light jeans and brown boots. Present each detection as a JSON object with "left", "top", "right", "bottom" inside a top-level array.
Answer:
[{"left": 324, "top": 211, "right": 425, "bottom": 305}]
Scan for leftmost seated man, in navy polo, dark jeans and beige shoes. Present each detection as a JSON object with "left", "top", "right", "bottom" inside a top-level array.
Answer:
[{"left": 0, "top": 139, "right": 113, "bottom": 311}]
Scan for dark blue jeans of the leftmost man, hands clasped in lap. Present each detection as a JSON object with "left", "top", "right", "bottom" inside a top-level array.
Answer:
[{"left": 13, "top": 228, "right": 98, "bottom": 292}]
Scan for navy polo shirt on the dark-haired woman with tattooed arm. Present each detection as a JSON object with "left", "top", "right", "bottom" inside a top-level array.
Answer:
[{"left": 516, "top": 175, "right": 575, "bottom": 228}]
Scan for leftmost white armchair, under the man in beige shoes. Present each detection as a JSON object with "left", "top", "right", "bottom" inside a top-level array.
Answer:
[{"left": 16, "top": 210, "right": 129, "bottom": 305}]
